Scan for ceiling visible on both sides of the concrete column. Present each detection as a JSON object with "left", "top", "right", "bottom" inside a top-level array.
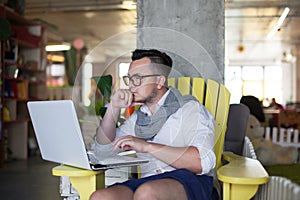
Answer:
[{"left": 25, "top": 0, "right": 300, "bottom": 65}]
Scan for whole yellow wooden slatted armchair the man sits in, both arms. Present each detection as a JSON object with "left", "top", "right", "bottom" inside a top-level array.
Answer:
[{"left": 52, "top": 77, "right": 268, "bottom": 200}]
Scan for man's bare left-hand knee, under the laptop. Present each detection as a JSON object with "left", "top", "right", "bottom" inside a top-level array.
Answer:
[{"left": 90, "top": 185, "right": 133, "bottom": 200}]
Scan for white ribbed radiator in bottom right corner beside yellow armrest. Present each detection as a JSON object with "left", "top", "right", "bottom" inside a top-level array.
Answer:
[{"left": 253, "top": 176, "right": 300, "bottom": 200}]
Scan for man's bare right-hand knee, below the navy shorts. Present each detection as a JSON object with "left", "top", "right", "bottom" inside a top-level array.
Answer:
[{"left": 134, "top": 178, "right": 187, "bottom": 200}]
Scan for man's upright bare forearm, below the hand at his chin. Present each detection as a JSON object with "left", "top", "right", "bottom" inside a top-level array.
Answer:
[{"left": 96, "top": 104, "right": 120, "bottom": 144}]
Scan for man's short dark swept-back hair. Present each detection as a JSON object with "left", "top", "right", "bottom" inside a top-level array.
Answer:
[{"left": 131, "top": 49, "right": 173, "bottom": 77}]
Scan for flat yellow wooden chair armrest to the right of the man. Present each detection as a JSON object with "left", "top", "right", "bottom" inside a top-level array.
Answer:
[{"left": 217, "top": 152, "right": 269, "bottom": 185}]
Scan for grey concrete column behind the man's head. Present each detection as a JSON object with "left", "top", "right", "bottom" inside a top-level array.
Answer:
[{"left": 137, "top": 0, "right": 224, "bottom": 82}]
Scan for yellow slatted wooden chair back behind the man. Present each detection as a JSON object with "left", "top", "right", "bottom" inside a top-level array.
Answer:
[{"left": 168, "top": 77, "right": 230, "bottom": 170}]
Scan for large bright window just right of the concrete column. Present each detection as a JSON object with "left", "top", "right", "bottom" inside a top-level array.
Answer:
[{"left": 225, "top": 66, "right": 283, "bottom": 103}]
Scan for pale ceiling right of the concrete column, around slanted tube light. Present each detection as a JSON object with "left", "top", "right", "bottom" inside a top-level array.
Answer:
[{"left": 225, "top": 0, "right": 300, "bottom": 64}]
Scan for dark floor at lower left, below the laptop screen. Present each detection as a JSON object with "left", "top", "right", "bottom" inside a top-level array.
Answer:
[{"left": 0, "top": 156, "right": 62, "bottom": 200}]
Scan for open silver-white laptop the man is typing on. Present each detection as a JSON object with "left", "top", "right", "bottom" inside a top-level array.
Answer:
[{"left": 27, "top": 100, "right": 148, "bottom": 170}]
